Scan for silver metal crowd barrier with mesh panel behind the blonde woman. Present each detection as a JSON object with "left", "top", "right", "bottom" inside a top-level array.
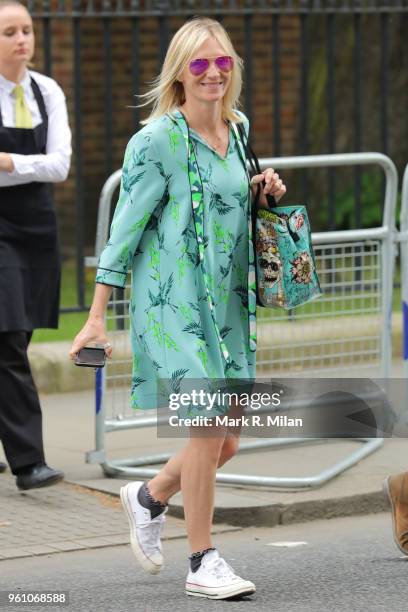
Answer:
[{"left": 86, "top": 153, "right": 398, "bottom": 488}]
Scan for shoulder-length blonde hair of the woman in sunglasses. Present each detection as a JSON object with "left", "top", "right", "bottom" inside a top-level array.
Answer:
[{"left": 139, "top": 17, "right": 243, "bottom": 124}]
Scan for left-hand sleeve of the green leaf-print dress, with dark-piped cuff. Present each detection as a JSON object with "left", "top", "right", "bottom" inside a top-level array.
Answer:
[{"left": 96, "top": 130, "right": 169, "bottom": 288}]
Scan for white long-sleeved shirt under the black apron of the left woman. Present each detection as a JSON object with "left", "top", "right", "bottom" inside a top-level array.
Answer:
[{"left": 0, "top": 70, "right": 72, "bottom": 187}]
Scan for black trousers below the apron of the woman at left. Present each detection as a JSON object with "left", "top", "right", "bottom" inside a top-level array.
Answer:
[{"left": 0, "top": 331, "right": 44, "bottom": 473}]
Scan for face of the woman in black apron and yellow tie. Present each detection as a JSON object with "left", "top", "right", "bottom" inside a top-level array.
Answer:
[{"left": 0, "top": 5, "right": 34, "bottom": 68}]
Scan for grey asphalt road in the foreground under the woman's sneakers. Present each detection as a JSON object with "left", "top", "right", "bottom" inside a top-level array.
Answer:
[{"left": 0, "top": 513, "right": 408, "bottom": 612}]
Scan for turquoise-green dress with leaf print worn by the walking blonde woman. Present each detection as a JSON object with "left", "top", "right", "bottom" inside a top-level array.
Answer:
[{"left": 96, "top": 111, "right": 256, "bottom": 409}]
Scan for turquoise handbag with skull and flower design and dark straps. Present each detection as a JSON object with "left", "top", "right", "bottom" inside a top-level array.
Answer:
[{"left": 236, "top": 124, "right": 322, "bottom": 310}]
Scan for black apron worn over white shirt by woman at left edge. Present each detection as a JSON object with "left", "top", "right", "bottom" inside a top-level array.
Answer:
[{"left": 0, "top": 79, "right": 60, "bottom": 332}]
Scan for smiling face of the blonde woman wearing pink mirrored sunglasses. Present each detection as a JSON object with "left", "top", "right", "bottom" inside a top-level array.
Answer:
[{"left": 180, "top": 37, "right": 231, "bottom": 103}]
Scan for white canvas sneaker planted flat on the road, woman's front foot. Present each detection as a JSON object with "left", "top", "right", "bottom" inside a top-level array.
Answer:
[{"left": 186, "top": 550, "right": 256, "bottom": 599}]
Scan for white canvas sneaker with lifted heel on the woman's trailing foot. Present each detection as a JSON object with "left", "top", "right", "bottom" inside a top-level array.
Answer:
[{"left": 120, "top": 482, "right": 167, "bottom": 574}]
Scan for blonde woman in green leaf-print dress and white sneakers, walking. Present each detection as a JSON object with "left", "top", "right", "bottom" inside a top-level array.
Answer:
[{"left": 70, "top": 18, "right": 286, "bottom": 599}]
